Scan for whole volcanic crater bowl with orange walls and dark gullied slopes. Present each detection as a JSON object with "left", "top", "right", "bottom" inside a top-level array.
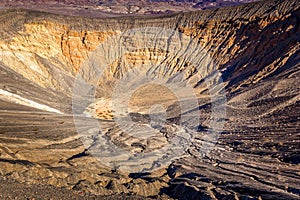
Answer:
[{"left": 0, "top": 0, "right": 300, "bottom": 199}]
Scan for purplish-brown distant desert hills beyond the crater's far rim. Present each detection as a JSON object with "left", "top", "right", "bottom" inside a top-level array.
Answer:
[{"left": 0, "top": 0, "right": 258, "bottom": 16}]
